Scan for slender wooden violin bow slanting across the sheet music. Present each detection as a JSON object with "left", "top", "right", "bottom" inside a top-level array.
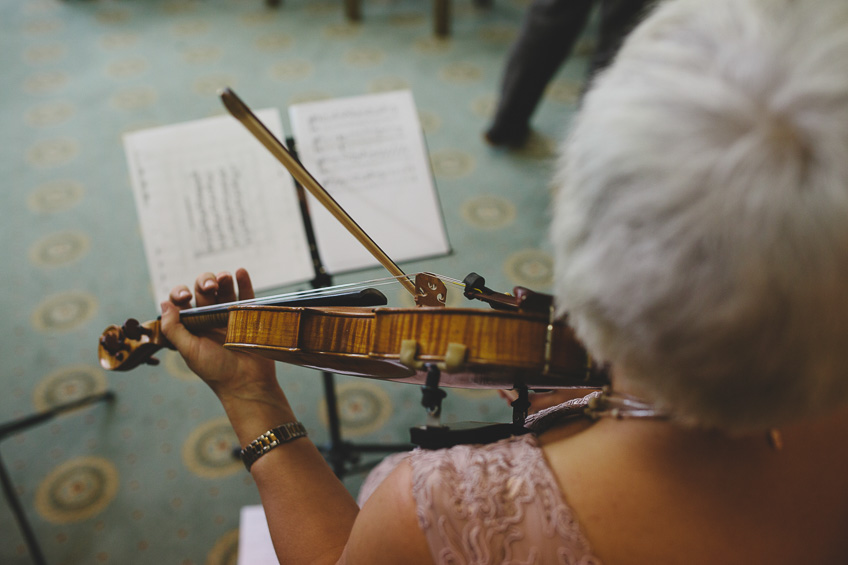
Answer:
[{"left": 219, "top": 88, "right": 419, "bottom": 297}]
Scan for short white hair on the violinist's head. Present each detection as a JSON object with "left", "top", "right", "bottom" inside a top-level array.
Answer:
[{"left": 551, "top": 0, "right": 848, "bottom": 432}]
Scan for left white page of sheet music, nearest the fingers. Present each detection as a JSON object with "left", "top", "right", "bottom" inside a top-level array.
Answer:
[{"left": 124, "top": 109, "right": 314, "bottom": 303}]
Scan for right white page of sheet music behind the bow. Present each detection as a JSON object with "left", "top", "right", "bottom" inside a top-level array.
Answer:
[{"left": 289, "top": 91, "right": 450, "bottom": 273}]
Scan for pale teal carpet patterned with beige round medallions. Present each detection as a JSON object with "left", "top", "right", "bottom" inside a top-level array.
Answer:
[{"left": 0, "top": 0, "right": 586, "bottom": 565}]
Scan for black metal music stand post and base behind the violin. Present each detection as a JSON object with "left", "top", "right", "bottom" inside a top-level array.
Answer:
[{"left": 286, "top": 137, "right": 413, "bottom": 479}]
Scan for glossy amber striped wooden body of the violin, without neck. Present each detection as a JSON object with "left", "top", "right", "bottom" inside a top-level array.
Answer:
[{"left": 224, "top": 306, "right": 606, "bottom": 389}]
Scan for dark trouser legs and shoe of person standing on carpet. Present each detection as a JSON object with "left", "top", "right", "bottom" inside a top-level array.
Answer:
[{"left": 487, "top": 0, "right": 651, "bottom": 145}]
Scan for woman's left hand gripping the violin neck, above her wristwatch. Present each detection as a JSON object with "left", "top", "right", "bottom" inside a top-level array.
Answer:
[{"left": 162, "top": 269, "right": 279, "bottom": 401}]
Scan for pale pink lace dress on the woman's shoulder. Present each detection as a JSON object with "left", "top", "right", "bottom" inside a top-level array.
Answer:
[{"left": 359, "top": 399, "right": 601, "bottom": 565}]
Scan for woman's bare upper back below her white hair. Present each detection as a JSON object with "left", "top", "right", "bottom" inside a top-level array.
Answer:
[{"left": 541, "top": 406, "right": 848, "bottom": 565}]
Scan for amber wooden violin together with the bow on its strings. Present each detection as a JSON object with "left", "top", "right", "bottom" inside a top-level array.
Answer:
[{"left": 98, "top": 89, "right": 608, "bottom": 389}]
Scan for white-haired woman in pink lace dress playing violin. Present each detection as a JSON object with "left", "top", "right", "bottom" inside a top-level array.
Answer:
[{"left": 162, "top": 0, "right": 848, "bottom": 565}]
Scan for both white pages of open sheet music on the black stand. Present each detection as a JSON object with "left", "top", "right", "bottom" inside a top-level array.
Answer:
[{"left": 124, "top": 92, "right": 450, "bottom": 302}]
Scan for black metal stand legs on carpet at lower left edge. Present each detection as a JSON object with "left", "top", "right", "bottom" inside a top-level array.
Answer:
[{"left": 0, "top": 391, "right": 115, "bottom": 565}]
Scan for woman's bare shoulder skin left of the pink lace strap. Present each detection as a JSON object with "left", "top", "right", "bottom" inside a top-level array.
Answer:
[{"left": 339, "top": 461, "right": 433, "bottom": 565}]
